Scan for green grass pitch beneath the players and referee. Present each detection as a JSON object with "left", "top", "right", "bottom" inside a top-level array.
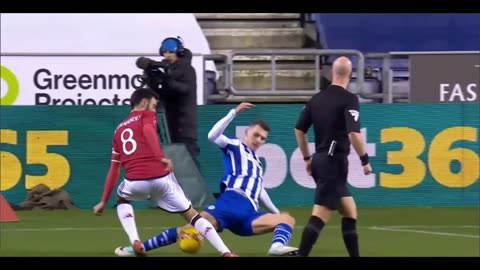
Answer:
[{"left": 0, "top": 207, "right": 480, "bottom": 257}]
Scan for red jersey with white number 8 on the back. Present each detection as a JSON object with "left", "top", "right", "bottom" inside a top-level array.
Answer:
[{"left": 112, "top": 111, "right": 170, "bottom": 180}]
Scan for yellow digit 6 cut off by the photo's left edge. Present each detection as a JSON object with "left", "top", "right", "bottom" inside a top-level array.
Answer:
[{"left": 0, "top": 129, "right": 22, "bottom": 191}]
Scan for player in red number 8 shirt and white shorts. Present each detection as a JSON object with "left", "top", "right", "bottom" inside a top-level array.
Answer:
[{"left": 93, "top": 88, "right": 236, "bottom": 257}]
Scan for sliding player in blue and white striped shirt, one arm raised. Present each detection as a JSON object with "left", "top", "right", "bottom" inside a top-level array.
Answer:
[{"left": 115, "top": 102, "right": 297, "bottom": 256}]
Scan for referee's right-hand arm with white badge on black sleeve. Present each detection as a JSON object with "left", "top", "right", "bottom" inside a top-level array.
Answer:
[{"left": 344, "top": 97, "right": 371, "bottom": 173}]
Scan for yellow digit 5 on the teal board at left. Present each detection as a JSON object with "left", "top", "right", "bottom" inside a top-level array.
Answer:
[{"left": 25, "top": 130, "right": 70, "bottom": 189}]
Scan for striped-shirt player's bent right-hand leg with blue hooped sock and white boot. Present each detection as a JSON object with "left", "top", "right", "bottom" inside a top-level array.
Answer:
[{"left": 250, "top": 213, "right": 298, "bottom": 256}]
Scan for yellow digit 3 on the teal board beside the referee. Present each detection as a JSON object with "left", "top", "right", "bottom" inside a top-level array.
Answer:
[{"left": 379, "top": 127, "right": 427, "bottom": 188}]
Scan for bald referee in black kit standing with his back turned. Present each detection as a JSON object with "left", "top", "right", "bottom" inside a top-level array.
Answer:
[{"left": 295, "top": 57, "right": 372, "bottom": 257}]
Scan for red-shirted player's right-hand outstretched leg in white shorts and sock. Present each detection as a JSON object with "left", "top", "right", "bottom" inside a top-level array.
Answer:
[{"left": 156, "top": 173, "right": 233, "bottom": 256}]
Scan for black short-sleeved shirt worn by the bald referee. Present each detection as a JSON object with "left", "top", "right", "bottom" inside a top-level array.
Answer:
[{"left": 295, "top": 85, "right": 360, "bottom": 155}]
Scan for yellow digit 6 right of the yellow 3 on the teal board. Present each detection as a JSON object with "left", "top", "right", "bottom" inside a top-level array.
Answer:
[{"left": 428, "top": 127, "right": 480, "bottom": 187}]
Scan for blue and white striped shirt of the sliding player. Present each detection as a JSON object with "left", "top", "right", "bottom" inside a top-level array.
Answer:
[{"left": 208, "top": 110, "right": 264, "bottom": 210}]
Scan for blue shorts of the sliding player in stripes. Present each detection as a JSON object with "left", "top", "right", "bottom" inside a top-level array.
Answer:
[{"left": 204, "top": 191, "right": 266, "bottom": 236}]
